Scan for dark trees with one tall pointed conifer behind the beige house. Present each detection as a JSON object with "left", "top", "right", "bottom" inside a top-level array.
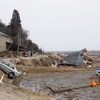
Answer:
[{"left": 0, "top": 9, "right": 42, "bottom": 53}]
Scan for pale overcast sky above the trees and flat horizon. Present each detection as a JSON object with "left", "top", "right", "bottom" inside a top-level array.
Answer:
[{"left": 0, "top": 0, "right": 100, "bottom": 51}]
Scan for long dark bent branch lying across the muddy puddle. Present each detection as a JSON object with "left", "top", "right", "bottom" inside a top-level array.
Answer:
[{"left": 45, "top": 85, "right": 92, "bottom": 93}]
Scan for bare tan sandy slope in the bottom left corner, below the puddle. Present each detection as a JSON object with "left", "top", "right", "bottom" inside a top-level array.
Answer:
[{"left": 0, "top": 83, "right": 54, "bottom": 100}]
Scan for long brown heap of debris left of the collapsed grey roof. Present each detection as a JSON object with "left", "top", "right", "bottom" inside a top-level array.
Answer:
[{"left": 12, "top": 55, "right": 62, "bottom": 67}]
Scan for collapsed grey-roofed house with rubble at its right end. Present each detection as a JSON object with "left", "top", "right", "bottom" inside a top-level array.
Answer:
[{"left": 60, "top": 50, "right": 93, "bottom": 67}]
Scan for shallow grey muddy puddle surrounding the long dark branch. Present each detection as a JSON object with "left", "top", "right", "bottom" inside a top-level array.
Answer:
[{"left": 20, "top": 72, "right": 100, "bottom": 100}]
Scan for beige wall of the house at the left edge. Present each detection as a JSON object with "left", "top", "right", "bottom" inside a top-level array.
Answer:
[{"left": 0, "top": 35, "right": 12, "bottom": 51}]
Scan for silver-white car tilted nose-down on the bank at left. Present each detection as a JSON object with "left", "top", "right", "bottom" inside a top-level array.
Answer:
[{"left": 0, "top": 61, "right": 21, "bottom": 79}]
